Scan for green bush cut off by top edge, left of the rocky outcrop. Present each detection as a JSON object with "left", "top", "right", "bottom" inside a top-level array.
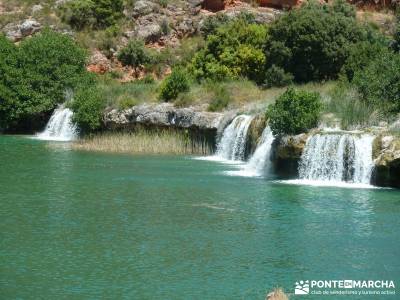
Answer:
[{"left": 60, "top": 0, "right": 124, "bottom": 30}]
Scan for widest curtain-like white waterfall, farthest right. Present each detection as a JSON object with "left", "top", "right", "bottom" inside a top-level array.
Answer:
[{"left": 299, "top": 133, "right": 374, "bottom": 184}]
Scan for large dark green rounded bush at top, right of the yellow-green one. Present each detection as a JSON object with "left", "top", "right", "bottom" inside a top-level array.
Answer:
[{"left": 266, "top": 0, "right": 365, "bottom": 82}]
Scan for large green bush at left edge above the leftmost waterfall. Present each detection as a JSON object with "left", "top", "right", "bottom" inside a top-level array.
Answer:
[{"left": 0, "top": 30, "right": 87, "bottom": 128}]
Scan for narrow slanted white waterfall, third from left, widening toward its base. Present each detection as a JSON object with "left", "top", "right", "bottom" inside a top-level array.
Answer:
[{"left": 228, "top": 126, "right": 274, "bottom": 177}]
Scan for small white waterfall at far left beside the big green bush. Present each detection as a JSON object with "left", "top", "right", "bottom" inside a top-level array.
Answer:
[{"left": 36, "top": 105, "right": 78, "bottom": 141}]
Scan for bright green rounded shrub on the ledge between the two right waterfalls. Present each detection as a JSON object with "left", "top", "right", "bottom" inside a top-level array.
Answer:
[{"left": 266, "top": 88, "right": 322, "bottom": 135}]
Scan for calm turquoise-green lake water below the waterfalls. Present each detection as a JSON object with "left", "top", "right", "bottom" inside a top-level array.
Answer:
[{"left": 0, "top": 136, "right": 400, "bottom": 299}]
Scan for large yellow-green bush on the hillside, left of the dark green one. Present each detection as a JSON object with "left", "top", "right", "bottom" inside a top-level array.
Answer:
[{"left": 189, "top": 19, "right": 267, "bottom": 82}]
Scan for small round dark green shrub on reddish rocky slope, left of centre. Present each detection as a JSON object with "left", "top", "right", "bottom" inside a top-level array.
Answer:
[{"left": 117, "top": 40, "right": 151, "bottom": 72}]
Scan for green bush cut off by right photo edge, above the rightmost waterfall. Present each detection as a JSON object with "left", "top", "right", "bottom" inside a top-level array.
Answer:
[{"left": 353, "top": 51, "right": 400, "bottom": 113}]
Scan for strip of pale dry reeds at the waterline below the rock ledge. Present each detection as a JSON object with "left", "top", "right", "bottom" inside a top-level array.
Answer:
[{"left": 72, "top": 129, "right": 212, "bottom": 155}]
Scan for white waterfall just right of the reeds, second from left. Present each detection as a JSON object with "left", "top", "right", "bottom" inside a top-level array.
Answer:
[{"left": 216, "top": 115, "right": 253, "bottom": 160}]
